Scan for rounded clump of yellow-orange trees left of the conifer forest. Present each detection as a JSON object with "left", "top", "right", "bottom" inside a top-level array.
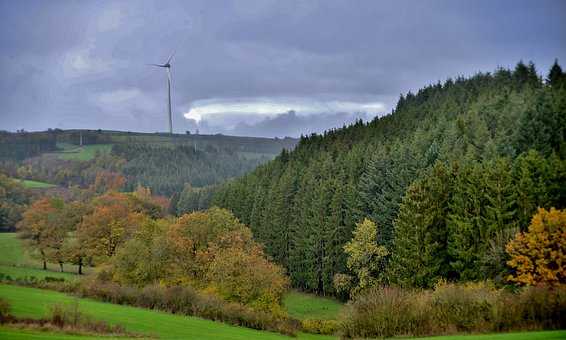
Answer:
[{"left": 110, "top": 208, "right": 288, "bottom": 313}]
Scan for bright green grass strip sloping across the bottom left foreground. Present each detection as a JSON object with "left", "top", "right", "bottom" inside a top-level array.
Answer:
[{"left": 0, "top": 285, "right": 332, "bottom": 340}]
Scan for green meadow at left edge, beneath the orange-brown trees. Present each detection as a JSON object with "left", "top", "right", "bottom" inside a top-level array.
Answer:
[{"left": 0, "top": 233, "right": 76, "bottom": 279}]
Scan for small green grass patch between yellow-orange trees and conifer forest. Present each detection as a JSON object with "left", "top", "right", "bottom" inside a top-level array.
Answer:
[{"left": 283, "top": 291, "right": 342, "bottom": 320}]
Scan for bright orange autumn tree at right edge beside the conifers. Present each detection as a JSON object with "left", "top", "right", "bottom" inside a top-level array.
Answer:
[{"left": 506, "top": 208, "right": 566, "bottom": 285}]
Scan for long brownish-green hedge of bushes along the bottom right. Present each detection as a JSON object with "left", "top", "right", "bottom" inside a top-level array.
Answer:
[{"left": 340, "top": 283, "right": 566, "bottom": 337}]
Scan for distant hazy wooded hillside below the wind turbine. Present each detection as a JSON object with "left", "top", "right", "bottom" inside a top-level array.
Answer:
[{"left": 0, "top": 129, "right": 297, "bottom": 196}]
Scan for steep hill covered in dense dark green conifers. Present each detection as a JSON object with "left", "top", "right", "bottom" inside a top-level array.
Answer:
[{"left": 213, "top": 62, "right": 566, "bottom": 294}]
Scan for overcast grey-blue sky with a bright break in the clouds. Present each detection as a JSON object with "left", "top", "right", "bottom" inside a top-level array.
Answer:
[{"left": 0, "top": 0, "right": 566, "bottom": 136}]
